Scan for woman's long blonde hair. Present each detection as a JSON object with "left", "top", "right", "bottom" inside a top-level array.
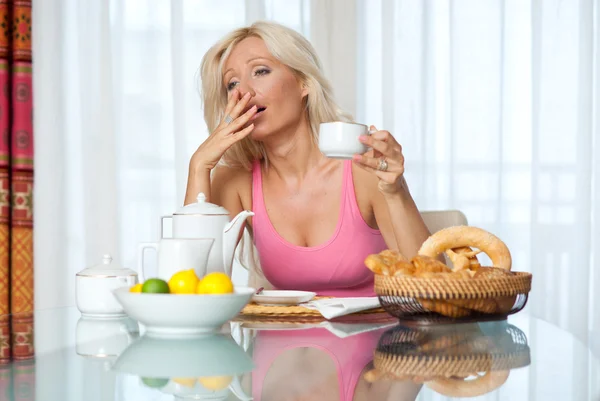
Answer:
[{"left": 200, "top": 21, "right": 353, "bottom": 170}]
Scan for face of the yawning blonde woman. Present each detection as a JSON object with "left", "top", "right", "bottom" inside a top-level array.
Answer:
[{"left": 223, "top": 37, "right": 307, "bottom": 141}]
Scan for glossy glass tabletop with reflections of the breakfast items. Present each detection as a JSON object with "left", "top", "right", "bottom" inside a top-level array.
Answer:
[{"left": 0, "top": 308, "right": 600, "bottom": 401}]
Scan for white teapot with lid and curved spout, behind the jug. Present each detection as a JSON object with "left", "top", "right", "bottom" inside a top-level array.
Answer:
[{"left": 160, "top": 192, "right": 254, "bottom": 276}]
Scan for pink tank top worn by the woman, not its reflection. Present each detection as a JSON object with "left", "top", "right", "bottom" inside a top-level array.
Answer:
[{"left": 252, "top": 160, "right": 387, "bottom": 297}]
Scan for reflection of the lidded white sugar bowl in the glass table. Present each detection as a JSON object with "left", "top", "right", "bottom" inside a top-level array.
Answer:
[{"left": 75, "top": 317, "right": 138, "bottom": 358}]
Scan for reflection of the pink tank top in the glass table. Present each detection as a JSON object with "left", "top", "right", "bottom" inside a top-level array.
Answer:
[{"left": 252, "top": 328, "right": 386, "bottom": 401}]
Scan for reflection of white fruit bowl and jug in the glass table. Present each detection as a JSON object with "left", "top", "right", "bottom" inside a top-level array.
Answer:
[{"left": 113, "top": 334, "right": 254, "bottom": 400}]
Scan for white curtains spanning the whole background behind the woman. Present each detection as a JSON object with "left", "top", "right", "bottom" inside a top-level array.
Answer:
[{"left": 34, "top": 0, "right": 600, "bottom": 341}]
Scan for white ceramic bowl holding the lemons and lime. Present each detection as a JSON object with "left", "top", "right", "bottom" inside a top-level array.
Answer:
[{"left": 113, "top": 287, "right": 255, "bottom": 338}]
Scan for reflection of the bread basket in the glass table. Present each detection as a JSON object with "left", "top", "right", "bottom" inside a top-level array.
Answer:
[{"left": 368, "top": 321, "right": 530, "bottom": 396}]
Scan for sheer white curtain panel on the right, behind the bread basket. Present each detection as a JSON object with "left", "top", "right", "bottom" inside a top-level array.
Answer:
[{"left": 356, "top": 0, "right": 600, "bottom": 341}]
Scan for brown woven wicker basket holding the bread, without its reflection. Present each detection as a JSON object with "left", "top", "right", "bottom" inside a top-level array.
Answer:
[{"left": 375, "top": 272, "right": 531, "bottom": 322}]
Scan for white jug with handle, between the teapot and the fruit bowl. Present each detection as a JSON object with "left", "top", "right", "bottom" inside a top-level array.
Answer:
[{"left": 138, "top": 238, "right": 215, "bottom": 282}]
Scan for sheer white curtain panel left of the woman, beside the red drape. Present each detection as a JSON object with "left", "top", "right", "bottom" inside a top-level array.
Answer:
[{"left": 34, "top": 0, "right": 310, "bottom": 309}]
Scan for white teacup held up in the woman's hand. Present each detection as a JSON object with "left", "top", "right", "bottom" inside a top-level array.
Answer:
[{"left": 319, "top": 121, "right": 369, "bottom": 159}]
